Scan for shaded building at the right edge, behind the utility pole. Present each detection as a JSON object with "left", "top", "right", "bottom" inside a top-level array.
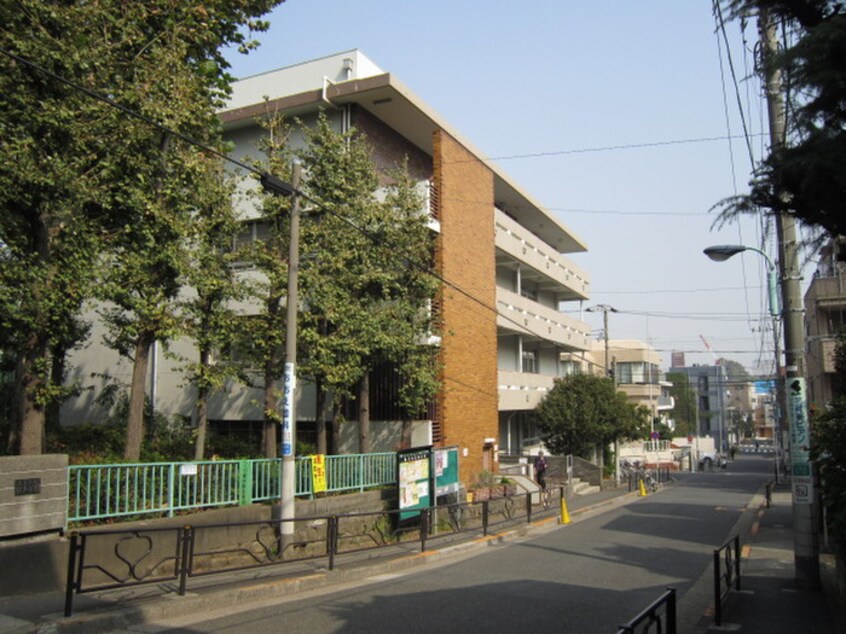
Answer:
[{"left": 805, "top": 236, "right": 846, "bottom": 407}]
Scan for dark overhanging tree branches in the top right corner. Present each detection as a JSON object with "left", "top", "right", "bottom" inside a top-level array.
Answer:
[{"left": 720, "top": 0, "right": 846, "bottom": 235}]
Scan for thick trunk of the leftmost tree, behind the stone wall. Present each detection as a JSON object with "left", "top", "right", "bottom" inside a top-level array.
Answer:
[{"left": 16, "top": 336, "right": 49, "bottom": 456}]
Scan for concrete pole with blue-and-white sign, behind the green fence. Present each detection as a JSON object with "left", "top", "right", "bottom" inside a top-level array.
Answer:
[{"left": 280, "top": 163, "right": 302, "bottom": 540}]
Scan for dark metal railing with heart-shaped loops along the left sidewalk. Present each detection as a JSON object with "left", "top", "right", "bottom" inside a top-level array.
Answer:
[{"left": 64, "top": 489, "right": 563, "bottom": 616}]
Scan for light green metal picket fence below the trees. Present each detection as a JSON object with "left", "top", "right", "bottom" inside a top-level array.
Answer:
[{"left": 67, "top": 453, "right": 396, "bottom": 523}]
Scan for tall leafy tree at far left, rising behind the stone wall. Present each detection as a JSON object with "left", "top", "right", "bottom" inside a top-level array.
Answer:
[{"left": 0, "top": 0, "right": 284, "bottom": 454}]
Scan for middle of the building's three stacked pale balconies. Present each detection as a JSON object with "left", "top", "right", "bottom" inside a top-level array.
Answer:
[{"left": 496, "top": 288, "right": 591, "bottom": 350}]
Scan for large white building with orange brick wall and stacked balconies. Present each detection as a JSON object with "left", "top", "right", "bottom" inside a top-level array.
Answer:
[{"left": 63, "top": 50, "right": 590, "bottom": 479}]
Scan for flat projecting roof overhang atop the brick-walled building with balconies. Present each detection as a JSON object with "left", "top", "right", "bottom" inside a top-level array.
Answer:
[{"left": 219, "top": 73, "right": 587, "bottom": 253}]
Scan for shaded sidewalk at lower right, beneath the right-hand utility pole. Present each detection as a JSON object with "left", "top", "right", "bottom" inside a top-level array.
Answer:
[{"left": 697, "top": 483, "right": 846, "bottom": 634}]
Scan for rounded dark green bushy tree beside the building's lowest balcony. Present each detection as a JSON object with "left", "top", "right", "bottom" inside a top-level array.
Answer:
[{"left": 535, "top": 374, "right": 648, "bottom": 456}]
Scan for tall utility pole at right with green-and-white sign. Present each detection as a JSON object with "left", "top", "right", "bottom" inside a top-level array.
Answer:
[{"left": 758, "top": 5, "right": 820, "bottom": 588}]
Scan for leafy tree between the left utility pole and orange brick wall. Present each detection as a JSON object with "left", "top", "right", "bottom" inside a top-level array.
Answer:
[{"left": 300, "top": 116, "right": 438, "bottom": 453}]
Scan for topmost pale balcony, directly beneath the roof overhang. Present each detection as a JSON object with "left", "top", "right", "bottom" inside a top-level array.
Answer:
[{"left": 496, "top": 209, "right": 590, "bottom": 301}]
